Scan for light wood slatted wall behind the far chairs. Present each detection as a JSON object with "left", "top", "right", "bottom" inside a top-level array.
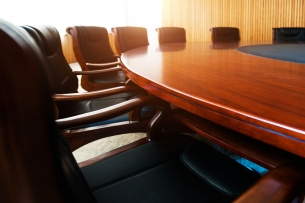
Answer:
[{"left": 162, "top": 0, "right": 305, "bottom": 41}]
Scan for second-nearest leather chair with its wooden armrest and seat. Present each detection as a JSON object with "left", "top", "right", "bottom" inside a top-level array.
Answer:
[{"left": 23, "top": 26, "right": 155, "bottom": 132}]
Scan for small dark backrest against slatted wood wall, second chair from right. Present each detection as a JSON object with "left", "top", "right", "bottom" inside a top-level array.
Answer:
[{"left": 210, "top": 27, "right": 240, "bottom": 42}]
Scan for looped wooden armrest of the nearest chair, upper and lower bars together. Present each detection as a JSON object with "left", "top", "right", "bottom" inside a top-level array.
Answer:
[{"left": 60, "top": 95, "right": 170, "bottom": 150}]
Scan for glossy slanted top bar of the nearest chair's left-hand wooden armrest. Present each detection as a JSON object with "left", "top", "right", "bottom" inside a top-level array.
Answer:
[{"left": 55, "top": 96, "right": 155, "bottom": 129}]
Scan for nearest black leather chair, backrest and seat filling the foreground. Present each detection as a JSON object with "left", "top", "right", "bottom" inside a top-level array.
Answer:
[{"left": 0, "top": 20, "right": 258, "bottom": 203}]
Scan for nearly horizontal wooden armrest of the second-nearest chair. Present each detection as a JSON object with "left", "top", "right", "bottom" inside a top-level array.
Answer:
[{"left": 53, "top": 86, "right": 144, "bottom": 101}]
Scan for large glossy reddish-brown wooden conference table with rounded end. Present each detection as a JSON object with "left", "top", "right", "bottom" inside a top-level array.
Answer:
[{"left": 121, "top": 41, "right": 305, "bottom": 165}]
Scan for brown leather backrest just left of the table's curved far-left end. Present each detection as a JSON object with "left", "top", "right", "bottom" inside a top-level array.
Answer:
[{"left": 66, "top": 26, "right": 117, "bottom": 70}]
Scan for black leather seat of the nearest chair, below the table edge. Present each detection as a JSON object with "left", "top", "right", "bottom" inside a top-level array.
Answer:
[{"left": 82, "top": 134, "right": 259, "bottom": 203}]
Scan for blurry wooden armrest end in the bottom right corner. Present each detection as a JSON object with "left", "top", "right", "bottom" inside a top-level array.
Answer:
[{"left": 234, "top": 164, "right": 305, "bottom": 203}]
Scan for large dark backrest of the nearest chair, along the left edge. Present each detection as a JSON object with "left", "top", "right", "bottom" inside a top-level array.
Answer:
[{"left": 0, "top": 20, "right": 95, "bottom": 203}]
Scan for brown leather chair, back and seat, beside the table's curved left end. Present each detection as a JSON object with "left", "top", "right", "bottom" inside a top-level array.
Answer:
[{"left": 66, "top": 26, "right": 128, "bottom": 91}]
